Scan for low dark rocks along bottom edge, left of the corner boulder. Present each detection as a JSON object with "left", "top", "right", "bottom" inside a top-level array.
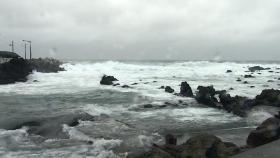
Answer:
[{"left": 135, "top": 134, "right": 240, "bottom": 158}]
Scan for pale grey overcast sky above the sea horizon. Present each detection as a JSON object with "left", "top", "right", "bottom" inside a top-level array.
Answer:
[{"left": 0, "top": 0, "right": 280, "bottom": 60}]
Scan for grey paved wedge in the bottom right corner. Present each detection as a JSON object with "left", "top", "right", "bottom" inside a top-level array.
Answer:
[{"left": 232, "top": 140, "right": 280, "bottom": 158}]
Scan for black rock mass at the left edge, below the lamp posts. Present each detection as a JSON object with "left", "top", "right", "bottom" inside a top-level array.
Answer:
[{"left": 0, "top": 58, "right": 32, "bottom": 84}]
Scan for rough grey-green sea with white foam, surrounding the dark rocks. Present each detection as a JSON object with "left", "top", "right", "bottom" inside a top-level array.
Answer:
[{"left": 0, "top": 61, "right": 280, "bottom": 158}]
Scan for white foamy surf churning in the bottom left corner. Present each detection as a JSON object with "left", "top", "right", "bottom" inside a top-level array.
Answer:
[{"left": 0, "top": 125, "right": 122, "bottom": 158}]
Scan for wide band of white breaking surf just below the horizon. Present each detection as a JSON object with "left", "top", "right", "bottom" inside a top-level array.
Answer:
[{"left": 0, "top": 61, "right": 279, "bottom": 98}]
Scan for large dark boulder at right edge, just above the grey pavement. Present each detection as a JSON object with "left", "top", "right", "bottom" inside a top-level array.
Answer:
[{"left": 247, "top": 117, "right": 280, "bottom": 147}]
